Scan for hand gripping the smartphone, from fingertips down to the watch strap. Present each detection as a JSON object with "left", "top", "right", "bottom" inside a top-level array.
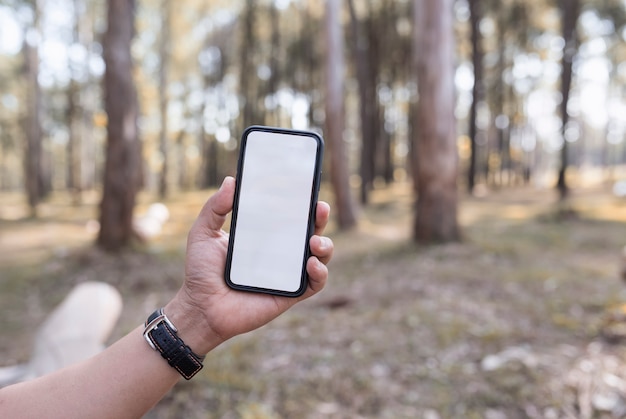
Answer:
[{"left": 165, "top": 177, "right": 333, "bottom": 355}]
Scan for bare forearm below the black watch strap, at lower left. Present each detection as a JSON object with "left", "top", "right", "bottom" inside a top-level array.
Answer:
[{"left": 0, "top": 327, "right": 180, "bottom": 418}]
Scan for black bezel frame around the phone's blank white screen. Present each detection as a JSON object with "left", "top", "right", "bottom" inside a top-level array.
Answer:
[{"left": 224, "top": 125, "right": 324, "bottom": 297}]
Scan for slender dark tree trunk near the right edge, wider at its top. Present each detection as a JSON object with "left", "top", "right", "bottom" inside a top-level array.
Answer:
[{"left": 556, "top": 0, "right": 580, "bottom": 201}]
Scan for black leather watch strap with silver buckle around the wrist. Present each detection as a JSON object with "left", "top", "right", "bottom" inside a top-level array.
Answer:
[{"left": 143, "top": 308, "right": 204, "bottom": 380}]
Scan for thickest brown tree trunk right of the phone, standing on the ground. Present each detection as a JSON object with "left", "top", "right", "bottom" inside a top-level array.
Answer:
[{"left": 413, "top": 0, "right": 459, "bottom": 243}]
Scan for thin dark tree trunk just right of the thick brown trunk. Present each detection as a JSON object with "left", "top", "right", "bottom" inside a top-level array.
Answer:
[{"left": 467, "top": 0, "right": 484, "bottom": 194}]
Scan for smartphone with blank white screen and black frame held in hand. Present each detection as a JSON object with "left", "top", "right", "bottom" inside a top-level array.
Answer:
[{"left": 225, "top": 126, "right": 324, "bottom": 297}]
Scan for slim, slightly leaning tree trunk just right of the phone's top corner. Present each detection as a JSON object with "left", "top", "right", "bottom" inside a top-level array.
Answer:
[{"left": 326, "top": 0, "right": 356, "bottom": 230}]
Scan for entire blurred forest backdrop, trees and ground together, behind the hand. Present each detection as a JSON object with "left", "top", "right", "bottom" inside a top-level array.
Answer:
[{"left": 0, "top": 0, "right": 626, "bottom": 417}]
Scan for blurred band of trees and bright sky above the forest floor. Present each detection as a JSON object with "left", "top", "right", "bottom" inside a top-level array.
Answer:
[{"left": 0, "top": 0, "right": 626, "bottom": 248}]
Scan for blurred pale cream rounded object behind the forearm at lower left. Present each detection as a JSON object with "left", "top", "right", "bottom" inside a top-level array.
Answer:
[{"left": 0, "top": 282, "right": 122, "bottom": 387}]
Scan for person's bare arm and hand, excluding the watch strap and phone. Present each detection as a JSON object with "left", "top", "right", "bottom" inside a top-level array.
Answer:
[{"left": 0, "top": 178, "right": 333, "bottom": 418}]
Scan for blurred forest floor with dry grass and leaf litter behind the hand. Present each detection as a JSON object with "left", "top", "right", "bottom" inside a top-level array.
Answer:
[{"left": 0, "top": 184, "right": 626, "bottom": 419}]
